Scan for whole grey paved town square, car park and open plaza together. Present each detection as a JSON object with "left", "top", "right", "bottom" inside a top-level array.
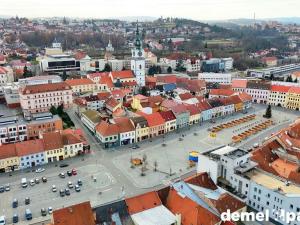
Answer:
[{"left": 0, "top": 105, "right": 299, "bottom": 224}]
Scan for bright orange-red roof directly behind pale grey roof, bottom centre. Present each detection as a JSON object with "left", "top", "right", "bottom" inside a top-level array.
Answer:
[{"left": 125, "top": 191, "right": 161, "bottom": 215}]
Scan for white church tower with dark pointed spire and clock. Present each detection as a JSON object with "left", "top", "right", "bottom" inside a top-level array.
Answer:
[{"left": 131, "top": 23, "right": 146, "bottom": 87}]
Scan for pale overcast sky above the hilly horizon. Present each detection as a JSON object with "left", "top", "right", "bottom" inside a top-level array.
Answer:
[{"left": 0, "top": 0, "right": 300, "bottom": 20}]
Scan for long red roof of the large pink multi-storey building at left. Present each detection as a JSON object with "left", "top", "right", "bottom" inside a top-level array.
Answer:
[{"left": 22, "top": 82, "right": 71, "bottom": 94}]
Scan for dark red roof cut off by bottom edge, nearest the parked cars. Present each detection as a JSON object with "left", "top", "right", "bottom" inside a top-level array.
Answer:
[{"left": 53, "top": 202, "right": 96, "bottom": 225}]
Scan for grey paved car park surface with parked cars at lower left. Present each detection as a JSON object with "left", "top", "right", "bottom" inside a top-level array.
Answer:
[{"left": 0, "top": 164, "right": 115, "bottom": 223}]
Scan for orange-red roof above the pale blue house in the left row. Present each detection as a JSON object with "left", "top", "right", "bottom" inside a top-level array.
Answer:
[{"left": 16, "top": 139, "right": 44, "bottom": 157}]
